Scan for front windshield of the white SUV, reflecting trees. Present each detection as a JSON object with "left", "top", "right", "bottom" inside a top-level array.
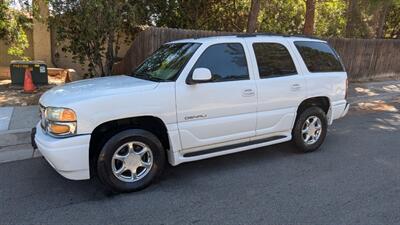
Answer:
[{"left": 132, "top": 43, "right": 200, "bottom": 81}]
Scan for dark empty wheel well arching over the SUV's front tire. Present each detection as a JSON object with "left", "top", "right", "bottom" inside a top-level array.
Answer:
[{"left": 89, "top": 116, "right": 170, "bottom": 174}]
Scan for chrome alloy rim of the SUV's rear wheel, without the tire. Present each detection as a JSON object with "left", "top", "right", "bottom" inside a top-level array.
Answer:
[{"left": 301, "top": 116, "right": 322, "bottom": 145}]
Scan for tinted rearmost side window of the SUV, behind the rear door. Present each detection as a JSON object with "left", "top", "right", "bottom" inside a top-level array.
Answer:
[{"left": 294, "top": 41, "right": 344, "bottom": 72}]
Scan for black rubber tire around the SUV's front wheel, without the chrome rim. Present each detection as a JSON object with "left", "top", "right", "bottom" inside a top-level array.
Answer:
[{"left": 97, "top": 129, "right": 166, "bottom": 192}]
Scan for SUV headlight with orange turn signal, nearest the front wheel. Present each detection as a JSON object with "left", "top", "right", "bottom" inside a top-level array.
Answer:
[{"left": 41, "top": 107, "right": 76, "bottom": 137}]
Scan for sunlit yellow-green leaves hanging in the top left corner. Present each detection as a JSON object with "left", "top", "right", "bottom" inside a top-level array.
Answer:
[{"left": 0, "top": 0, "right": 32, "bottom": 59}]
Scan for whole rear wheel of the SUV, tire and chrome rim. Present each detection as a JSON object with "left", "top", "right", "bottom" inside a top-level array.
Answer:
[{"left": 292, "top": 106, "right": 328, "bottom": 152}]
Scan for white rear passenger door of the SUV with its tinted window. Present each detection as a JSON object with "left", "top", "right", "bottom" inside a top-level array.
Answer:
[{"left": 244, "top": 38, "right": 306, "bottom": 137}]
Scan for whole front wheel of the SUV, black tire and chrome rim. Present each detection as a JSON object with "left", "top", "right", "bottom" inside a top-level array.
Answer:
[{"left": 97, "top": 129, "right": 165, "bottom": 192}]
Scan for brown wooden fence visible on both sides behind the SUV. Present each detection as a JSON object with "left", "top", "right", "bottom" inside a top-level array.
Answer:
[{"left": 113, "top": 27, "right": 400, "bottom": 81}]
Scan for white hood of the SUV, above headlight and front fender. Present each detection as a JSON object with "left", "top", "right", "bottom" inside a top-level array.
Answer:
[{"left": 39, "top": 75, "right": 158, "bottom": 107}]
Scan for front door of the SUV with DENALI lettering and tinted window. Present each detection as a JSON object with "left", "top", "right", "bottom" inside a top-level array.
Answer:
[{"left": 176, "top": 43, "right": 257, "bottom": 151}]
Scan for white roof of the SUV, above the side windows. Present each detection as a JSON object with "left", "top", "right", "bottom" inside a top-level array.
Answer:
[{"left": 169, "top": 33, "right": 326, "bottom": 43}]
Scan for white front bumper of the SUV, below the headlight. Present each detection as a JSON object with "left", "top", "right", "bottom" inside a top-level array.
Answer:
[{"left": 32, "top": 124, "right": 90, "bottom": 180}]
